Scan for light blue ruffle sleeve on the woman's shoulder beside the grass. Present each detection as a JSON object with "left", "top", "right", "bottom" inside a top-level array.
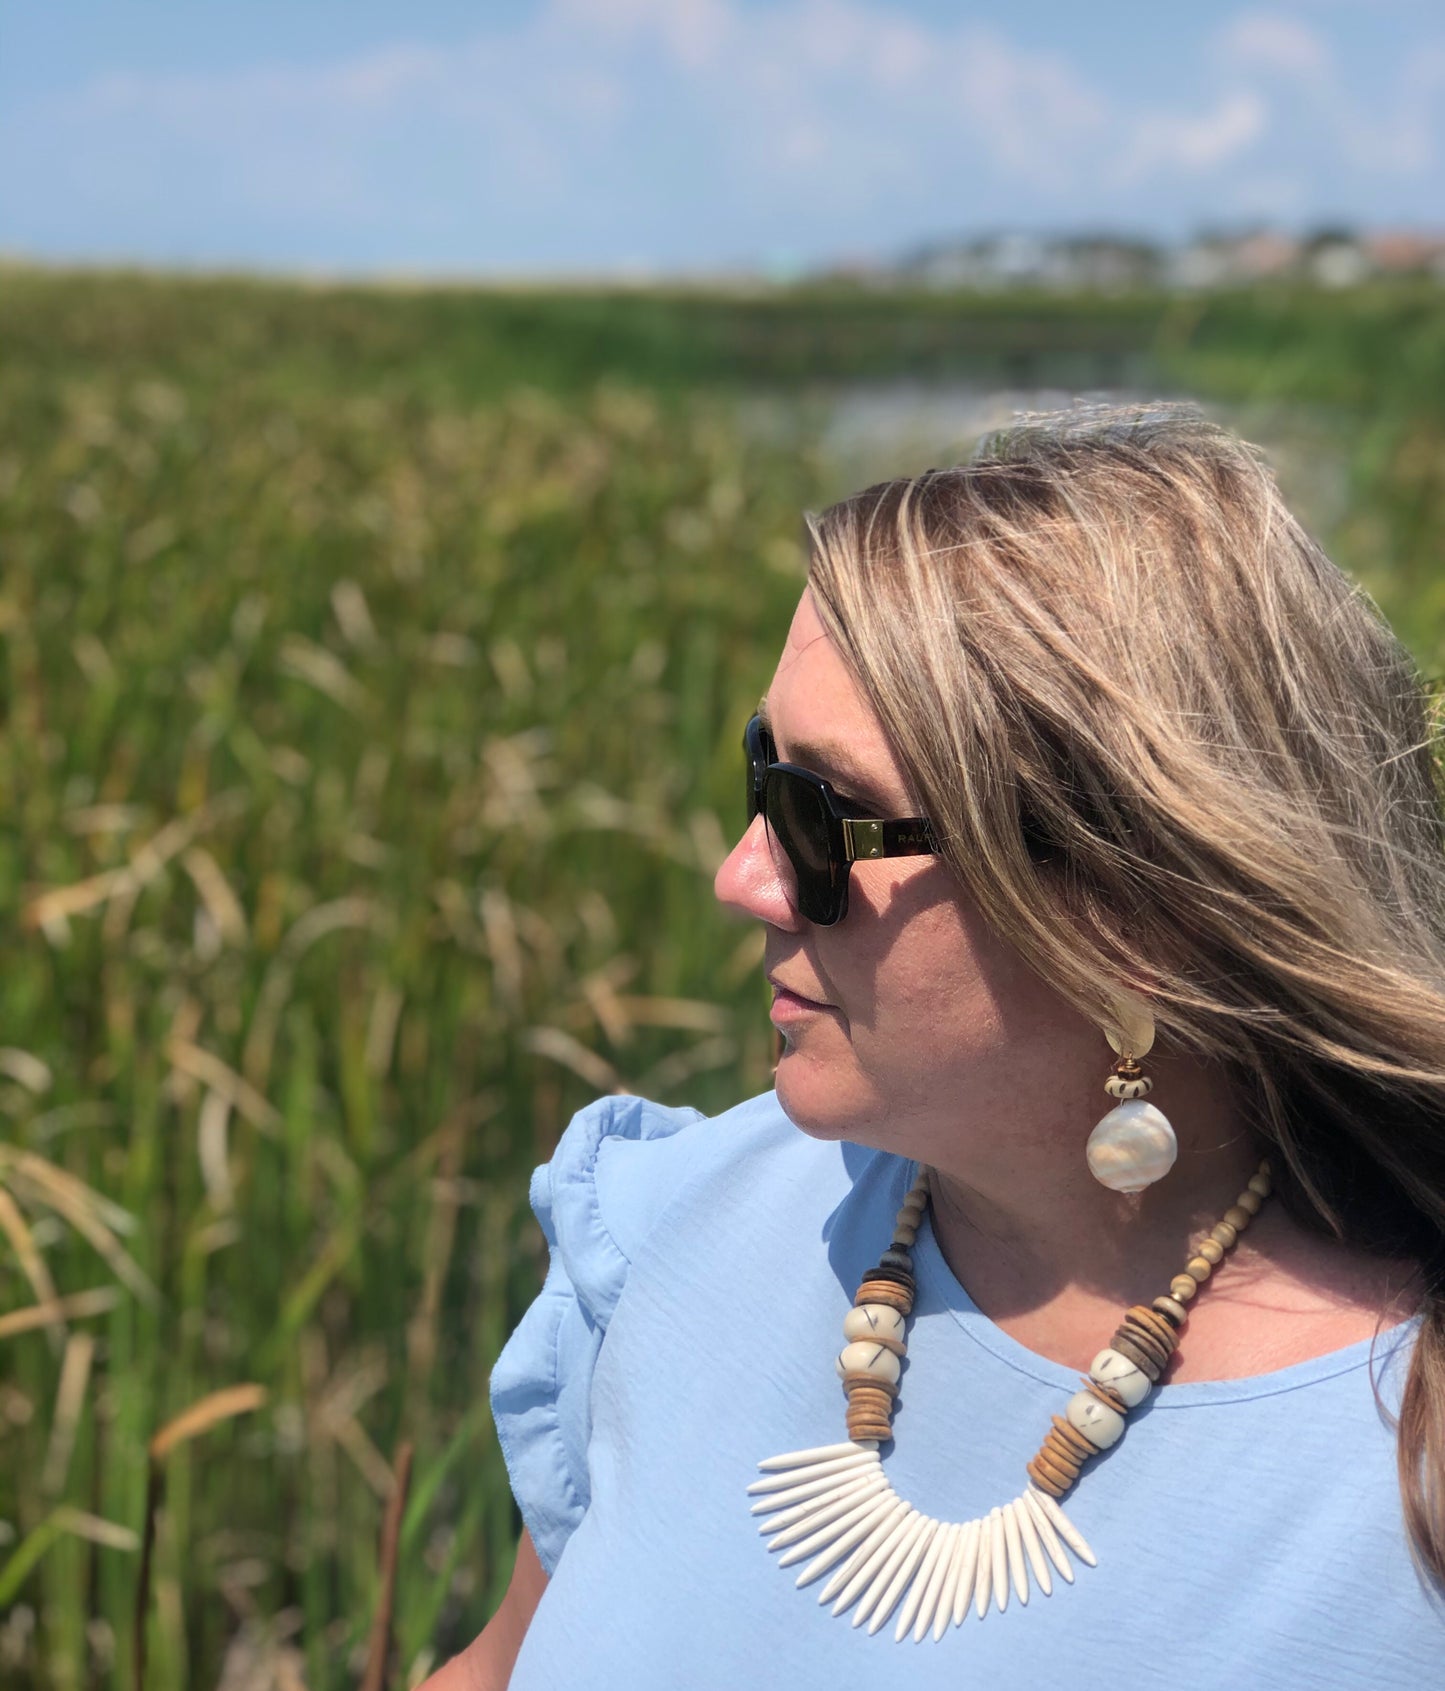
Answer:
[{"left": 490, "top": 1097, "right": 703, "bottom": 1574}]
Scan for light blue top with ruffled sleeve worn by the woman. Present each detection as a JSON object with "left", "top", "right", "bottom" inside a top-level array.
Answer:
[{"left": 492, "top": 1092, "right": 1445, "bottom": 1691}]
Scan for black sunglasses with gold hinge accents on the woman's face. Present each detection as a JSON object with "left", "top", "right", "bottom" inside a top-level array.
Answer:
[{"left": 742, "top": 717, "right": 938, "bottom": 928}]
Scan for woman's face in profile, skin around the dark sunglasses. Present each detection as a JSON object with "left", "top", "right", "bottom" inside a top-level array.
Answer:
[{"left": 715, "top": 592, "right": 1102, "bottom": 1163}]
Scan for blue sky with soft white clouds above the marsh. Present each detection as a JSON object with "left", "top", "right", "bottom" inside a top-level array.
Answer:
[{"left": 0, "top": 0, "right": 1445, "bottom": 276}]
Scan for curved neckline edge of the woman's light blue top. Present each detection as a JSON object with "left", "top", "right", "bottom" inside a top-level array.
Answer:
[{"left": 899, "top": 1158, "right": 1420, "bottom": 1412}]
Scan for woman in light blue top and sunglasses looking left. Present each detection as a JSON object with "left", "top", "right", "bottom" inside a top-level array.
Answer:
[{"left": 425, "top": 408, "right": 1445, "bottom": 1691}]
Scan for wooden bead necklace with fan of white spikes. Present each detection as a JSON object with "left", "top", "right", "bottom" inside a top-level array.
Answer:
[{"left": 747, "top": 1162, "right": 1269, "bottom": 1640}]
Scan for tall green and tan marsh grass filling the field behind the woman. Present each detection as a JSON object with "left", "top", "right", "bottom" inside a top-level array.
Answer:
[{"left": 0, "top": 271, "right": 1445, "bottom": 1691}]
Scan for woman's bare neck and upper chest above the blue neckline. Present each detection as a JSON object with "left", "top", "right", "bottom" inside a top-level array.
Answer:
[{"left": 928, "top": 1064, "right": 1415, "bottom": 1382}]
